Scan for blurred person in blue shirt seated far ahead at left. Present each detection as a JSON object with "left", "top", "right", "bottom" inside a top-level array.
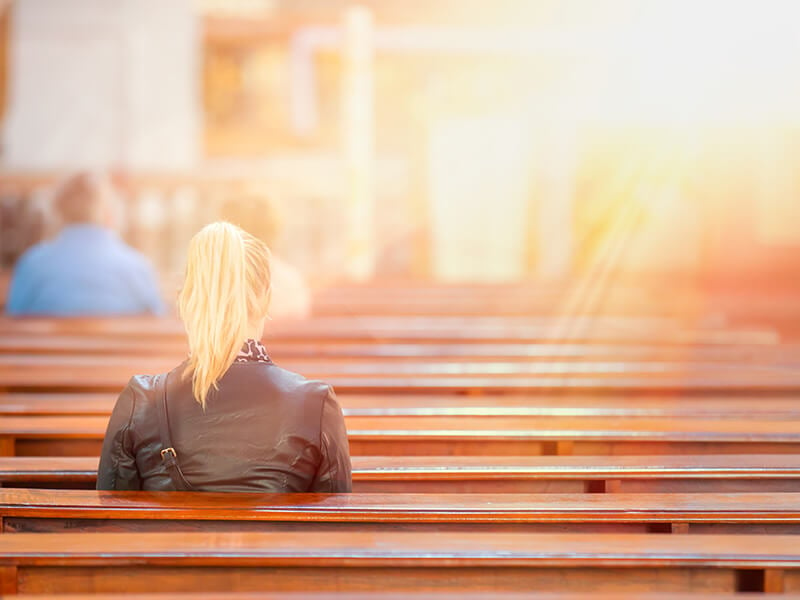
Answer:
[{"left": 6, "top": 173, "right": 164, "bottom": 317}]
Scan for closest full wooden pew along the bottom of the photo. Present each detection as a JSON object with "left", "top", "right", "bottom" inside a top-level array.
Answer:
[{"left": 0, "top": 531, "right": 800, "bottom": 594}]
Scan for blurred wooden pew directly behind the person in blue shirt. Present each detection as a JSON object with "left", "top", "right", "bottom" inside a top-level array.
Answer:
[{"left": 0, "top": 316, "right": 780, "bottom": 345}]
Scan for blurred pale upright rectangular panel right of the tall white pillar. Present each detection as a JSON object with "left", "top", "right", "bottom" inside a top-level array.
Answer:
[{"left": 429, "top": 115, "right": 531, "bottom": 282}]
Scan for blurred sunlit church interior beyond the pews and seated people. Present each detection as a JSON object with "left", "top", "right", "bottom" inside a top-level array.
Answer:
[{"left": 0, "top": 0, "right": 800, "bottom": 322}]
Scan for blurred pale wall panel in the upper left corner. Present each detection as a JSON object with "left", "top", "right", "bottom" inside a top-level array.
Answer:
[{"left": 4, "top": 0, "right": 201, "bottom": 170}]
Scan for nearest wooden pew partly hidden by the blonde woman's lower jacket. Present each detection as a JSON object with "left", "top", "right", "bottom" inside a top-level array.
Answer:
[{"left": 0, "top": 454, "right": 800, "bottom": 494}]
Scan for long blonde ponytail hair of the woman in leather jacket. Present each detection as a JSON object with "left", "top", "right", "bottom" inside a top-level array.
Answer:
[{"left": 178, "top": 221, "right": 270, "bottom": 410}]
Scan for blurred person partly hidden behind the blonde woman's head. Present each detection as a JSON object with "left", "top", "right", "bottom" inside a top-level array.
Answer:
[{"left": 222, "top": 195, "right": 311, "bottom": 320}]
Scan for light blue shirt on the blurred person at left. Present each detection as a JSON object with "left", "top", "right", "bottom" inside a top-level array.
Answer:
[{"left": 6, "top": 224, "right": 164, "bottom": 316}]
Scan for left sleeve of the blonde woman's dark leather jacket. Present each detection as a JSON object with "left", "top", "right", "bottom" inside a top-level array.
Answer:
[{"left": 97, "top": 382, "right": 141, "bottom": 490}]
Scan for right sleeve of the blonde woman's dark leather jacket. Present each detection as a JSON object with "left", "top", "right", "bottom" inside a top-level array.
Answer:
[{"left": 309, "top": 386, "right": 353, "bottom": 493}]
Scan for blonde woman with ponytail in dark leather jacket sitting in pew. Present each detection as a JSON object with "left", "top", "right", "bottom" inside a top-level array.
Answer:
[{"left": 97, "top": 223, "right": 352, "bottom": 492}]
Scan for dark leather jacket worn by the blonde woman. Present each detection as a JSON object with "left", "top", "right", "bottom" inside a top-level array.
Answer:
[{"left": 97, "top": 346, "right": 352, "bottom": 492}]
